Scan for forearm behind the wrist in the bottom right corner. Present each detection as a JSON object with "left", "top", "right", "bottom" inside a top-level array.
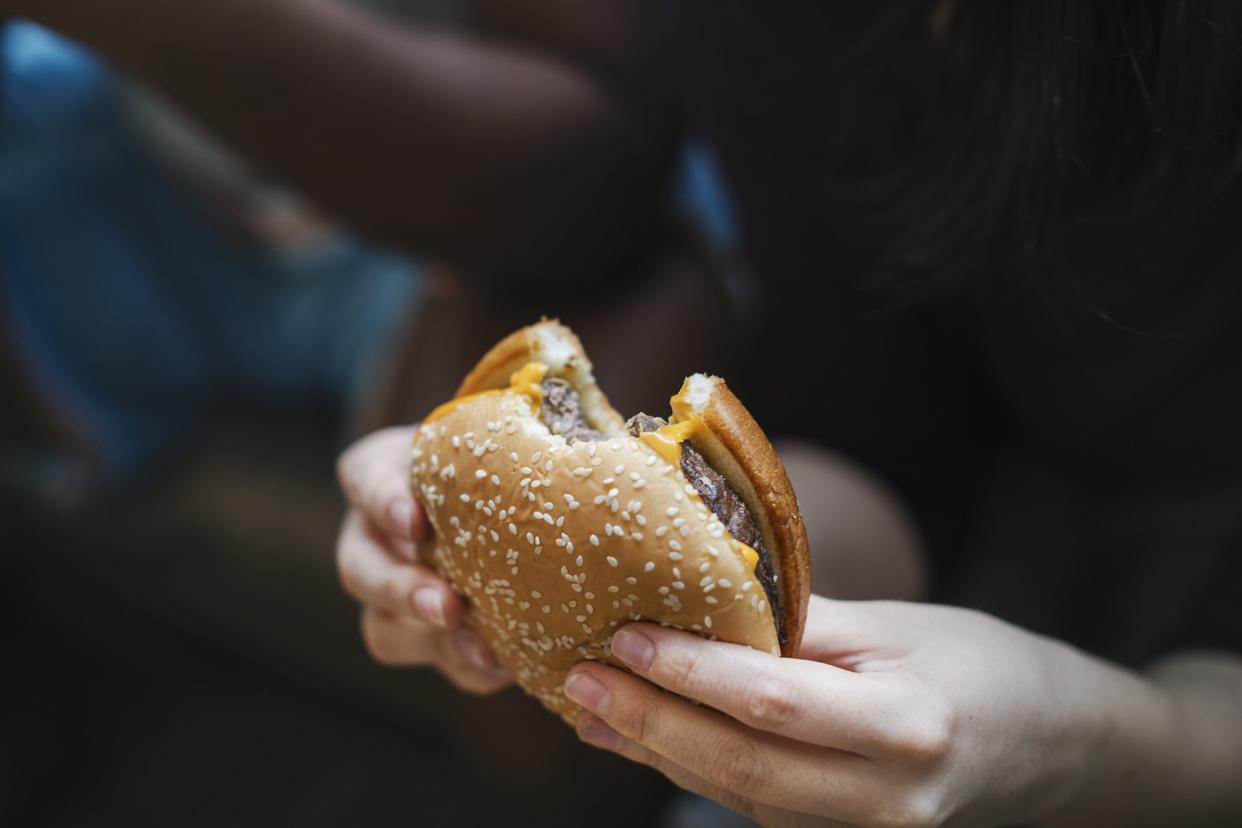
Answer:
[{"left": 1043, "top": 654, "right": 1242, "bottom": 826}]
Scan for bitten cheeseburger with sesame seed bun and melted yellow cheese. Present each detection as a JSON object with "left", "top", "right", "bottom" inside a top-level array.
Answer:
[{"left": 411, "top": 322, "right": 810, "bottom": 721}]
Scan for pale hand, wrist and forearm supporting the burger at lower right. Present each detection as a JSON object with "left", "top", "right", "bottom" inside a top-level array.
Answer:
[{"left": 565, "top": 598, "right": 1242, "bottom": 826}]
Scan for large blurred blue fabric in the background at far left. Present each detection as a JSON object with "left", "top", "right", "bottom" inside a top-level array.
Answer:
[{"left": 0, "top": 22, "right": 420, "bottom": 491}]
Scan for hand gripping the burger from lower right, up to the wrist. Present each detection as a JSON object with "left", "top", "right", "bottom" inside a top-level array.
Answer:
[{"left": 565, "top": 597, "right": 1095, "bottom": 826}]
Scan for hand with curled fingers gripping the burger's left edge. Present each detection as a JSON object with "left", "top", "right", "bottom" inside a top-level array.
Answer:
[{"left": 337, "top": 428, "right": 510, "bottom": 694}]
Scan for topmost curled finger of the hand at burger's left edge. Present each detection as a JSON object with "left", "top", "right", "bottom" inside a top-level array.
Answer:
[{"left": 337, "top": 427, "right": 427, "bottom": 542}]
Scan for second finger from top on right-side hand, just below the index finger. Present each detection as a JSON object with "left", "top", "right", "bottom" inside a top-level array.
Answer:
[{"left": 565, "top": 662, "right": 874, "bottom": 818}]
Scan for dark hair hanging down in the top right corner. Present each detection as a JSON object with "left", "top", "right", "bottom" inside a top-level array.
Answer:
[{"left": 871, "top": 0, "right": 1242, "bottom": 303}]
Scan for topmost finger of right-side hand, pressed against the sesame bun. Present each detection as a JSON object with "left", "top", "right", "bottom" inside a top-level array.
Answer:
[{"left": 612, "top": 624, "right": 917, "bottom": 756}]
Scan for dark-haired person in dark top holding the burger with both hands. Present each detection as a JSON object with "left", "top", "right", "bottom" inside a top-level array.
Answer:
[{"left": 4, "top": 0, "right": 1242, "bottom": 826}]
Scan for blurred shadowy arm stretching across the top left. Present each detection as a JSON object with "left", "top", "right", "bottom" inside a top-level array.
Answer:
[{"left": 14, "top": 0, "right": 676, "bottom": 278}]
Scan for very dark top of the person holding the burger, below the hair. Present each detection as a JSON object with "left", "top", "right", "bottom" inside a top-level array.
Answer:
[{"left": 663, "top": 0, "right": 1242, "bottom": 662}]
